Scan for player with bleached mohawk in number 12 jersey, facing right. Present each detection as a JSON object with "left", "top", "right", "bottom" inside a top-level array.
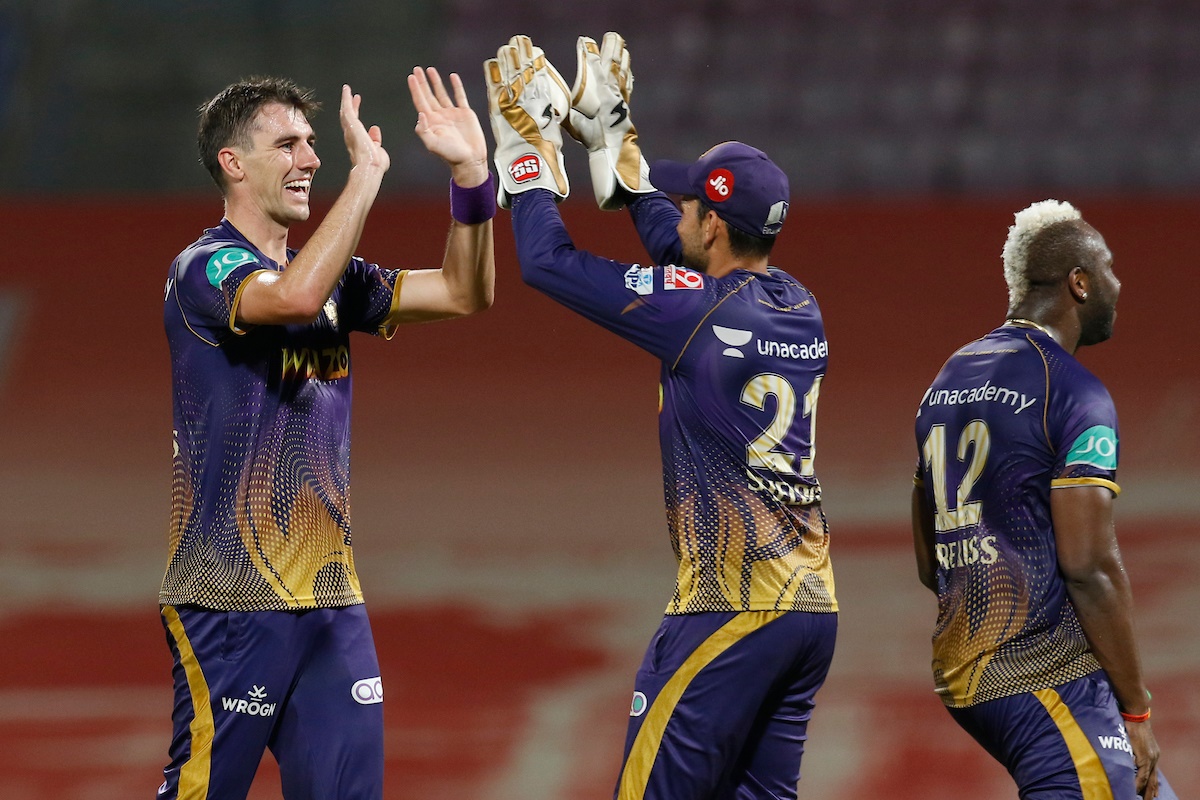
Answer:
[{"left": 912, "top": 200, "right": 1175, "bottom": 800}]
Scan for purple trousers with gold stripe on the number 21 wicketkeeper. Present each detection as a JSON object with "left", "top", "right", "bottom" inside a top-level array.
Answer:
[{"left": 617, "top": 612, "right": 838, "bottom": 800}]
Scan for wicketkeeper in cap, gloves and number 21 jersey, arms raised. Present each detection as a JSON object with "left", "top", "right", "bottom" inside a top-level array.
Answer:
[{"left": 485, "top": 34, "right": 838, "bottom": 800}]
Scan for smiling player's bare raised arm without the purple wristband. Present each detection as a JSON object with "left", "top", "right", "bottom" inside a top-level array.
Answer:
[{"left": 236, "top": 85, "right": 391, "bottom": 325}]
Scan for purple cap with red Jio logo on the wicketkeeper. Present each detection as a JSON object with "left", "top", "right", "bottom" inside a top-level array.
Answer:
[{"left": 650, "top": 142, "right": 788, "bottom": 236}]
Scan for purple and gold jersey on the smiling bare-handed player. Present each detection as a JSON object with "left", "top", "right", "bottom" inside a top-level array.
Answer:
[{"left": 160, "top": 219, "right": 403, "bottom": 610}]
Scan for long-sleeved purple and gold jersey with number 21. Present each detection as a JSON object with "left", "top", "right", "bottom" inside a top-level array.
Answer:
[{"left": 512, "top": 192, "right": 838, "bottom": 614}]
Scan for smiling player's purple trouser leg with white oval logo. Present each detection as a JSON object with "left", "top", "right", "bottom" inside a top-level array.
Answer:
[{"left": 270, "top": 604, "right": 384, "bottom": 800}]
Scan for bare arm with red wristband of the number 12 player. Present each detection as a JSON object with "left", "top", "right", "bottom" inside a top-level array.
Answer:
[{"left": 1050, "top": 486, "right": 1159, "bottom": 798}]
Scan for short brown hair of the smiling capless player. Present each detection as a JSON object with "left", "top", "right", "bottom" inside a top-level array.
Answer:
[{"left": 196, "top": 77, "right": 320, "bottom": 192}]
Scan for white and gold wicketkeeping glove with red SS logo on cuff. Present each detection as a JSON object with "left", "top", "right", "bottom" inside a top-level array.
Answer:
[{"left": 484, "top": 35, "right": 571, "bottom": 209}]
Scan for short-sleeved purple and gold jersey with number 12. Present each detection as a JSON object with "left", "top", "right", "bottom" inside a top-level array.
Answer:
[{"left": 916, "top": 323, "right": 1120, "bottom": 708}]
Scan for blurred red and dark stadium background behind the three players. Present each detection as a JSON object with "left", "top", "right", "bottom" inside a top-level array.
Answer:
[{"left": 0, "top": 0, "right": 1200, "bottom": 800}]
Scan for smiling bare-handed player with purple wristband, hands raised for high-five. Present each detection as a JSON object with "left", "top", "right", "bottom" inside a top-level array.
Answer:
[{"left": 158, "top": 67, "right": 496, "bottom": 800}]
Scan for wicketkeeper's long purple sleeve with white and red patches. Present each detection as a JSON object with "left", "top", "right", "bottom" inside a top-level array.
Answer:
[{"left": 512, "top": 190, "right": 719, "bottom": 362}]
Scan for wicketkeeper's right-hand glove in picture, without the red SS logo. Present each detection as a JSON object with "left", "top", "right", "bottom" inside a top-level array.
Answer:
[{"left": 565, "top": 32, "right": 654, "bottom": 211}]
